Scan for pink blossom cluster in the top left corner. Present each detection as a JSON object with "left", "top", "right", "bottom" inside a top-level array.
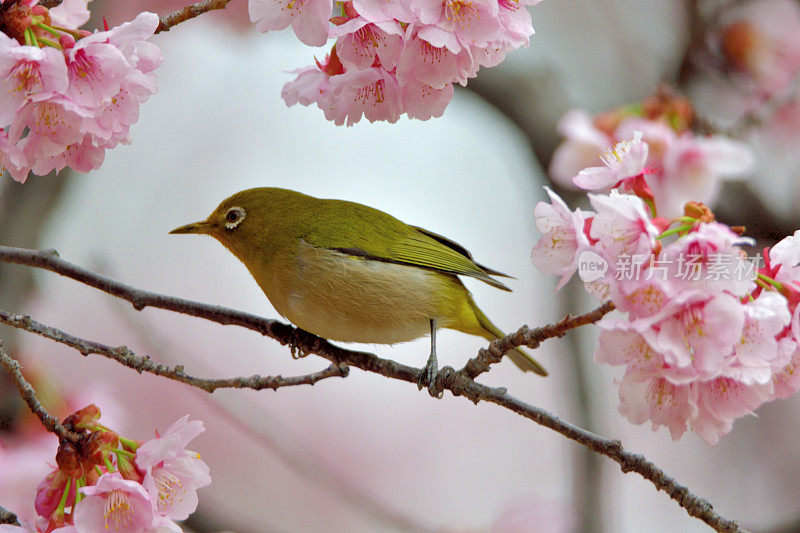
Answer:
[{"left": 0, "top": 0, "right": 162, "bottom": 182}]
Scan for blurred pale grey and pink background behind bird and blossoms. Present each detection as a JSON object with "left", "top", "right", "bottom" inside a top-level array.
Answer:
[{"left": 0, "top": 0, "right": 800, "bottom": 533}]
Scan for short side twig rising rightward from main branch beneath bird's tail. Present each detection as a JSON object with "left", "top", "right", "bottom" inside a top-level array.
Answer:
[{"left": 459, "top": 302, "right": 614, "bottom": 379}]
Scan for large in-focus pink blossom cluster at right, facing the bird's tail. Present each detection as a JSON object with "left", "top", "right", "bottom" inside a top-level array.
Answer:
[{"left": 531, "top": 134, "right": 800, "bottom": 444}]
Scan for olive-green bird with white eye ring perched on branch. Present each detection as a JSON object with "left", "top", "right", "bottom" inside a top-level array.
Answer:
[{"left": 170, "top": 187, "right": 547, "bottom": 390}]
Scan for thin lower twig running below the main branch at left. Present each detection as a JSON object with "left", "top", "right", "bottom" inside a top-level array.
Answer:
[{"left": 0, "top": 310, "right": 350, "bottom": 392}]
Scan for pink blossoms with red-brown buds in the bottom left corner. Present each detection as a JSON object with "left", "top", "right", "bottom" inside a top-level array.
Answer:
[{"left": 22, "top": 405, "right": 211, "bottom": 533}]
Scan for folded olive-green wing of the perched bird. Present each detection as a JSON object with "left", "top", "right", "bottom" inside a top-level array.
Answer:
[{"left": 305, "top": 204, "right": 511, "bottom": 291}]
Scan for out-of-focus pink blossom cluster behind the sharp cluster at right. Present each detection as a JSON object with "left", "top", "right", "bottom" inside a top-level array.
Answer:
[{"left": 549, "top": 96, "right": 753, "bottom": 216}]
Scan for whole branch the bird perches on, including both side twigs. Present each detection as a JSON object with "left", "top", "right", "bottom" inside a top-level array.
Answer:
[{"left": 0, "top": 246, "right": 744, "bottom": 531}]
